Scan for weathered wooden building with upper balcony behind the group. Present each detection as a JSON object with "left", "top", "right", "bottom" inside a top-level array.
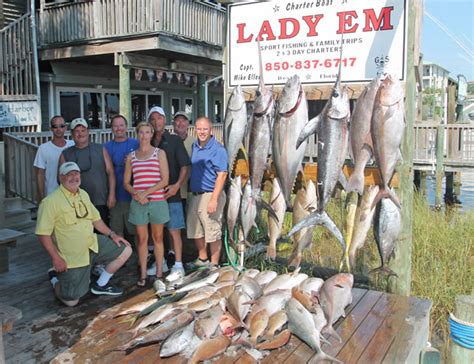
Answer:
[{"left": 0, "top": 0, "right": 225, "bottom": 129}]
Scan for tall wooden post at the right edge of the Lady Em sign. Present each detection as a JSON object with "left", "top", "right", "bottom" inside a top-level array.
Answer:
[{"left": 388, "top": 0, "right": 423, "bottom": 296}]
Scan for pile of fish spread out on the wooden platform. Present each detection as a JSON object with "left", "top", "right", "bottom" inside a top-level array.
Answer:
[{"left": 115, "top": 267, "right": 353, "bottom": 363}]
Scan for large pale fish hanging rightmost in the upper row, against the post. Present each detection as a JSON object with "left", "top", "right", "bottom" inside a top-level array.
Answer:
[{"left": 370, "top": 76, "right": 405, "bottom": 208}]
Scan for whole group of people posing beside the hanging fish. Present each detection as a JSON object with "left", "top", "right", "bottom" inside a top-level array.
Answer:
[{"left": 34, "top": 106, "right": 227, "bottom": 306}]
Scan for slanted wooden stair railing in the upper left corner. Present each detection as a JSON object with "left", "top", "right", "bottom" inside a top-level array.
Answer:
[{"left": 0, "top": 13, "right": 37, "bottom": 100}]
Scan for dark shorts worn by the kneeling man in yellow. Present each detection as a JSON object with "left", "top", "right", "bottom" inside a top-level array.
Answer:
[{"left": 58, "top": 235, "right": 125, "bottom": 301}]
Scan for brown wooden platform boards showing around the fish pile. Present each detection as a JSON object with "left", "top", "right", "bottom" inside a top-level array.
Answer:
[{"left": 53, "top": 288, "right": 431, "bottom": 364}]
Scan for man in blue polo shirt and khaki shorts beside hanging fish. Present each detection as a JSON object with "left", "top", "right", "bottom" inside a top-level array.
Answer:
[{"left": 186, "top": 117, "right": 227, "bottom": 267}]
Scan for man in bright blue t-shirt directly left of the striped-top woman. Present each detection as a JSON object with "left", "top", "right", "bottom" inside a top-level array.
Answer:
[{"left": 104, "top": 115, "right": 139, "bottom": 236}]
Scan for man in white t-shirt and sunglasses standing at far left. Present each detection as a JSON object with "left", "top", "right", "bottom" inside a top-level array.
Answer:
[{"left": 33, "top": 115, "right": 74, "bottom": 204}]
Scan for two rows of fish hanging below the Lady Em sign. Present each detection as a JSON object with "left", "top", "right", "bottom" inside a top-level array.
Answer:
[{"left": 224, "top": 69, "right": 405, "bottom": 274}]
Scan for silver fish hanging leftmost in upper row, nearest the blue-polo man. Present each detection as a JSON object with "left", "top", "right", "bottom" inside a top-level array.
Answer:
[{"left": 224, "top": 86, "right": 247, "bottom": 175}]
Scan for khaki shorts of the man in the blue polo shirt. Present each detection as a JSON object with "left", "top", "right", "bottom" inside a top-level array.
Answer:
[{"left": 186, "top": 191, "right": 226, "bottom": 243}]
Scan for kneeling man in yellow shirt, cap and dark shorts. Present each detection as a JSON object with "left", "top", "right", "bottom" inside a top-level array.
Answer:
[{"left": 35, "top": 162, "right": 132, "bottom": 306}]
